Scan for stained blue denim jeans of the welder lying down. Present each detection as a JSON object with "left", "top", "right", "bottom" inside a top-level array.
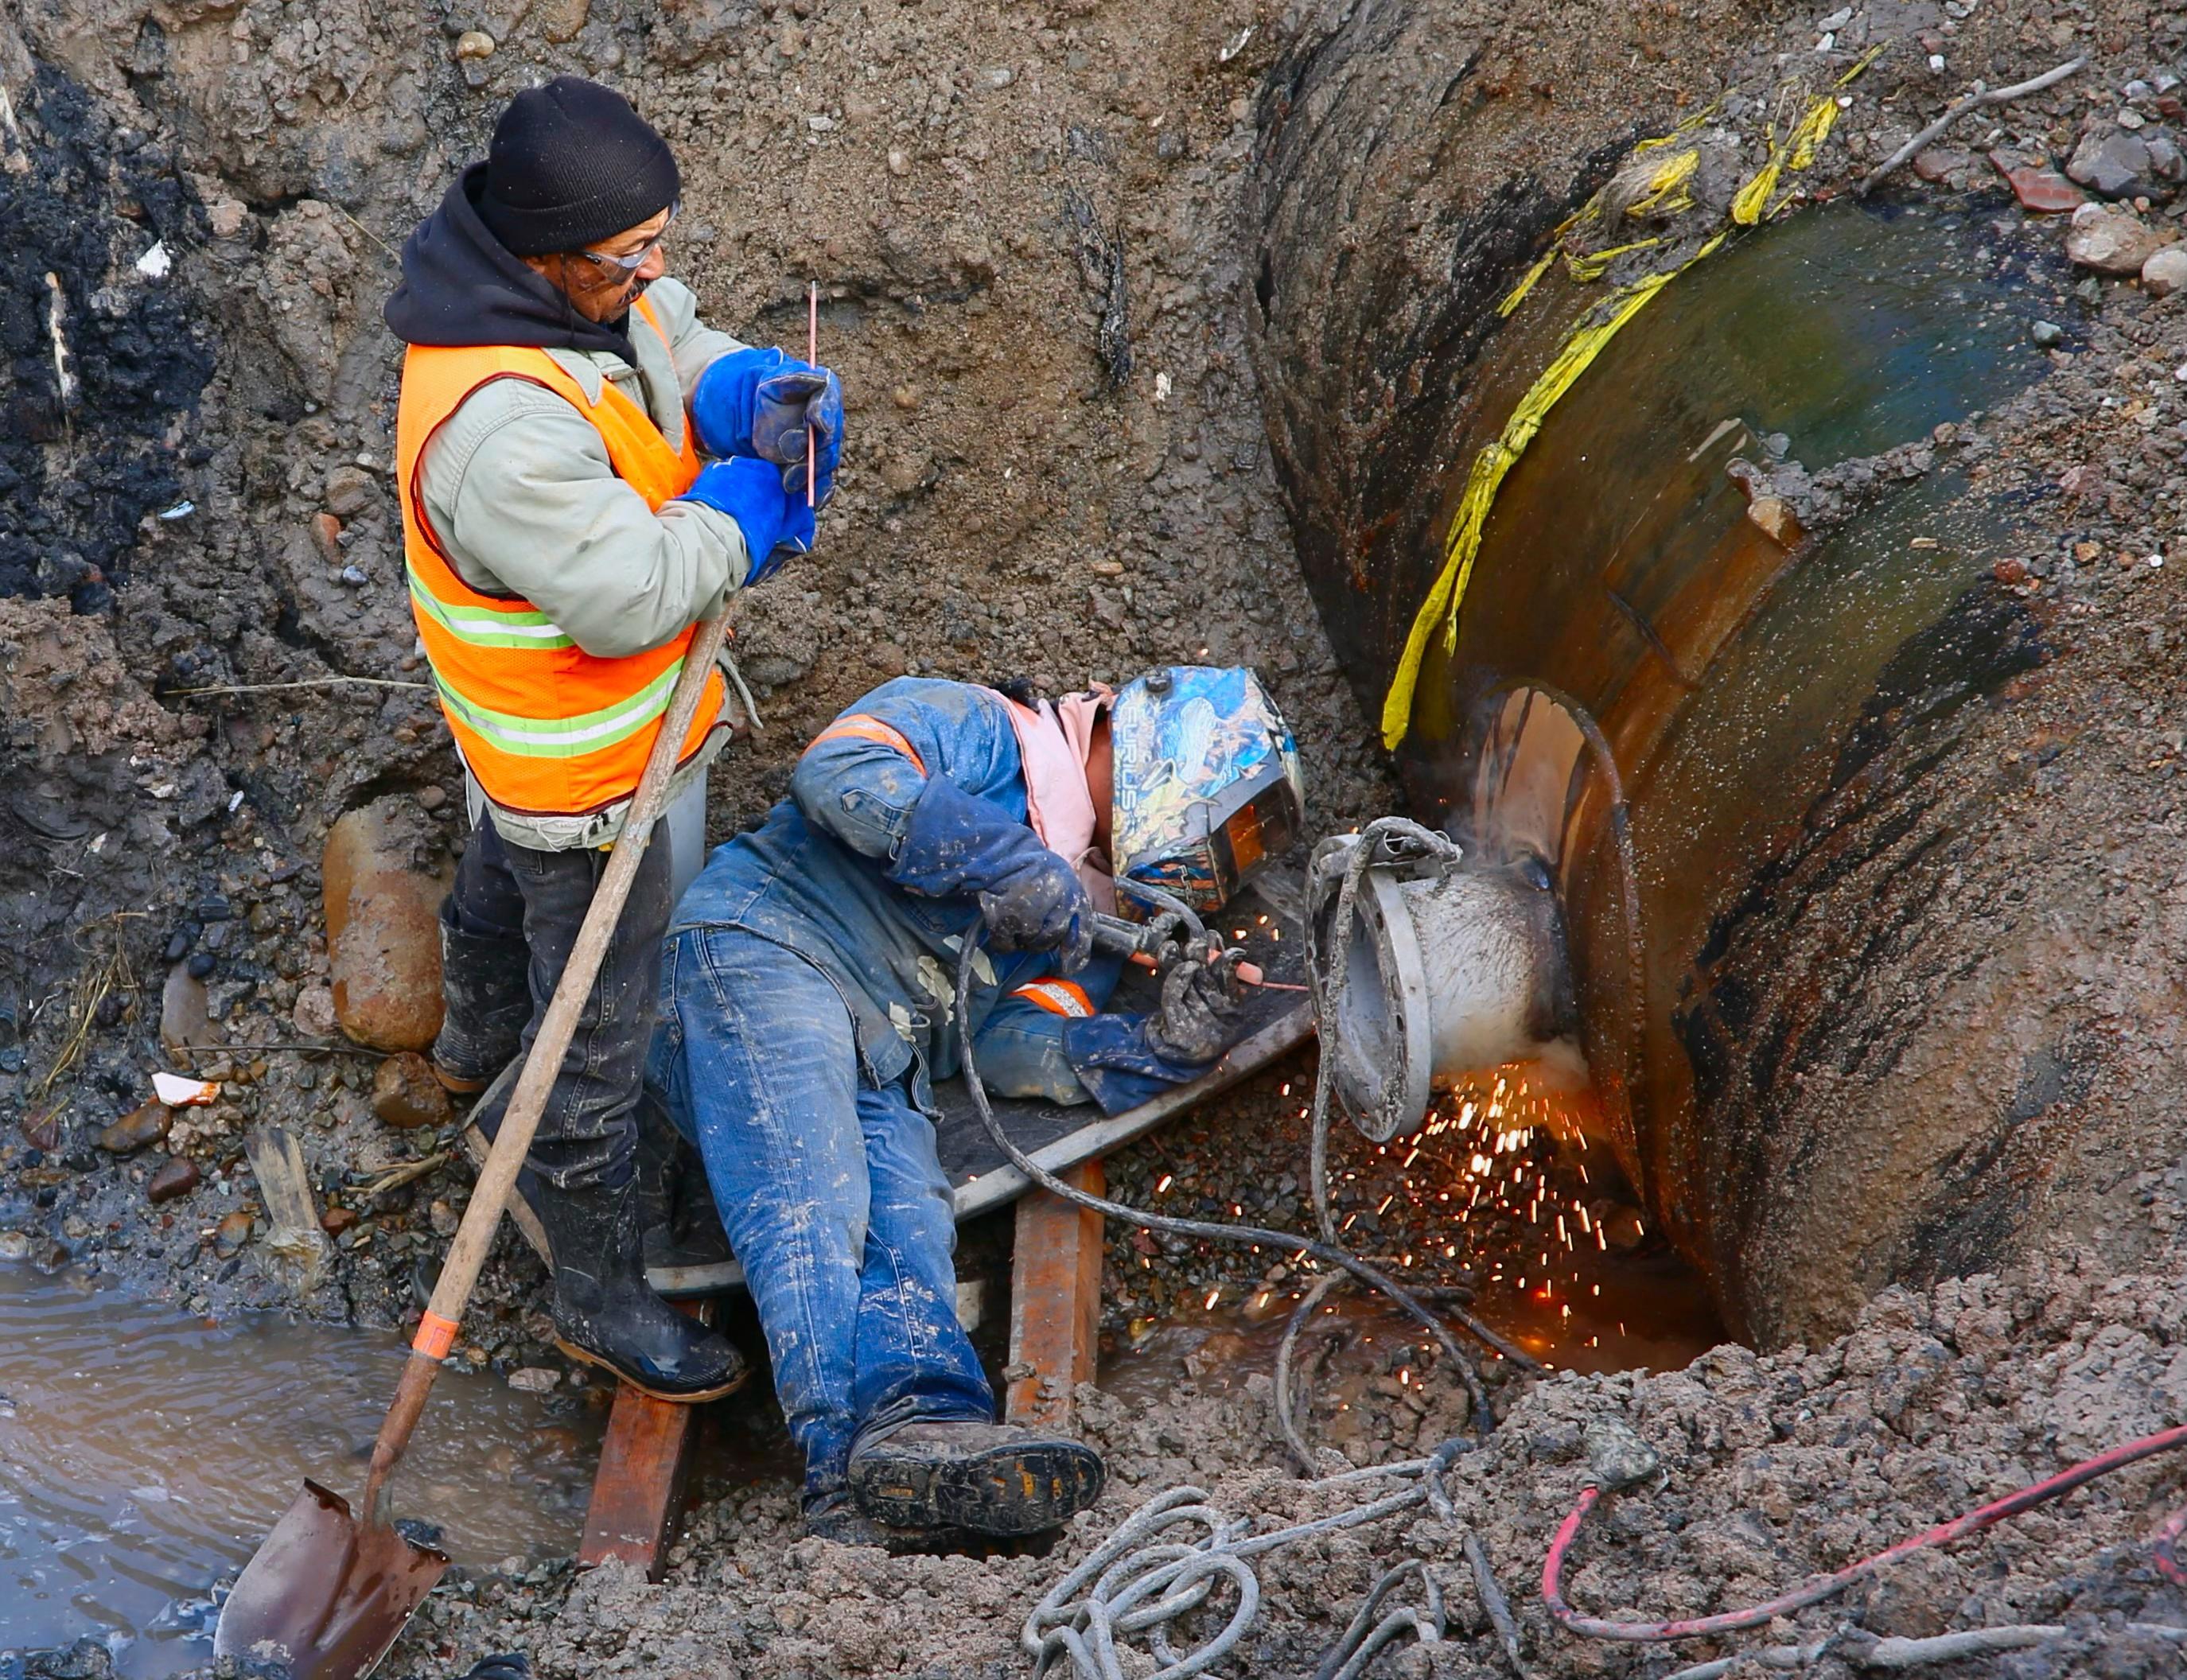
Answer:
[{"left": 648, "top": 928, "right": 995, "bottom": 1510}]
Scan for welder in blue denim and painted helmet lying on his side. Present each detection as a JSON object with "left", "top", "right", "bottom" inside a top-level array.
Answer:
[{"left": 649, "top": 667, "right": 1302, "bottom": 1546}]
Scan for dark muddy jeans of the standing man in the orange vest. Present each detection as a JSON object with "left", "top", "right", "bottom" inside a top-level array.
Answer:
[{"left": 449, "top": 820, "right": 674, "bottom": 1190}]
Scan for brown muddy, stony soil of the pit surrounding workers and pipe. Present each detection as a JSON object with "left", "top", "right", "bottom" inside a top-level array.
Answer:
[{"left": 0, "top": 0, "right": 2187, "bottom": 1678}]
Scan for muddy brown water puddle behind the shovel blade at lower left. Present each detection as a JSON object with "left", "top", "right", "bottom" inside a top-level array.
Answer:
[{"left": 0, "top": 1265, "right": 601, "bottom": 1680}]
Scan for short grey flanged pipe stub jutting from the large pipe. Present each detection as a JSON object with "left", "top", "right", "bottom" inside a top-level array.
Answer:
[{"left": 1308, "top": 836, "right": 1574, "bottom": 1142}]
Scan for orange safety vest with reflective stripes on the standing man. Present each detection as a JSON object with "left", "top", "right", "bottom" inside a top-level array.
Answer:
[{"left": 396, "top": 298, "right": 722, "bottom": 816}]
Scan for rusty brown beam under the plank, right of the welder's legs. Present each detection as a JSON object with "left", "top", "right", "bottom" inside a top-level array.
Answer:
[{"left": 1002, "top": 1161, "right": 1107, "bottom": 1431}]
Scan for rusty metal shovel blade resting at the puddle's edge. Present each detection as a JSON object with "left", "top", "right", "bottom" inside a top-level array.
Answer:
[{"left": 212, "top": 1481, "right": 449, "bottom": 1680}]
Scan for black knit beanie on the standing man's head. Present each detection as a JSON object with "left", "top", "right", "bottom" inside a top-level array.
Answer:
[{"left": 479, "top": 76, "right": 680, "bottom": 256}]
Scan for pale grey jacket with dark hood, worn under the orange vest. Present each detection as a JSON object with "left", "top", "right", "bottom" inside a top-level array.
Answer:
[{"left": 387, "top": 164, "right": 748, "bottom": 851}]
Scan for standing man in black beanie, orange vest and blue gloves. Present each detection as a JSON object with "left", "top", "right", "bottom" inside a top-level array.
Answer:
[{"left": 387, "top": 76, "right": 842, "bottom": 1400}]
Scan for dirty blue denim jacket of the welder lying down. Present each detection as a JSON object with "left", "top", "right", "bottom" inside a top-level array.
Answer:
[{"left": 669, "top": 676, "right": 1198, "bottom": 1111}]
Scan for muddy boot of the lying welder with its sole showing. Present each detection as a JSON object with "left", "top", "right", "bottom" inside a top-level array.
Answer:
[{"left": 850, "top": 1420, "right": 1104, "bottom": 1536}]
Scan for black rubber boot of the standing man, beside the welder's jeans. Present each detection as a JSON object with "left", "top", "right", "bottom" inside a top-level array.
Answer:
[{"left": 536, "top": 1184, "right": 750, "bottom": 1405}]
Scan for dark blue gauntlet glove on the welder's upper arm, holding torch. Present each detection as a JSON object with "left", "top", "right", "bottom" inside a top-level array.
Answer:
[{"left": 888, "top": 776, "right": 1094, "bottom": 974}]
